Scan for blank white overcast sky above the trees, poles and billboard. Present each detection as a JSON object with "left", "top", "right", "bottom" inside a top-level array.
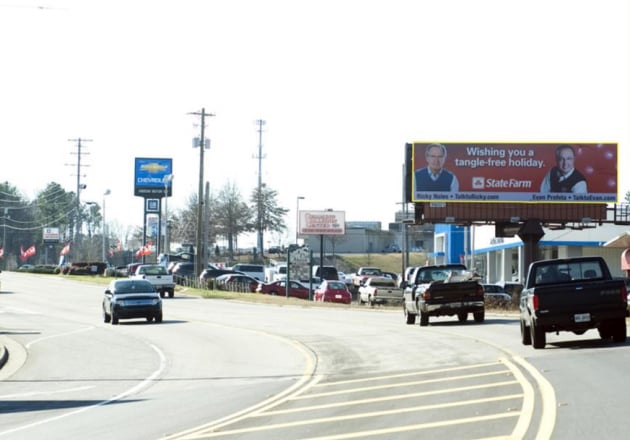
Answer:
[{"left": 0, "top": 0, "right": 630, "bottom": 248}]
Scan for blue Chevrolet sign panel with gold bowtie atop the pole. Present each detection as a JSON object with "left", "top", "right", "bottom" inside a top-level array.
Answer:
[{"left": 133, "top": 157, "right": 173, "bottom": 198}]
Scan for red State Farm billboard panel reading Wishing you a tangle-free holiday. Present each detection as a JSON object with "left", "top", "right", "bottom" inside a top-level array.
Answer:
[{"left": 409, "top": 142, "right": 618, "bottom": 203}]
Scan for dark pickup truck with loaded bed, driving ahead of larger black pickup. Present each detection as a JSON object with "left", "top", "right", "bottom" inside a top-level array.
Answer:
[{"left": 403, "top": 264, "right": 485, "bottom": 326}]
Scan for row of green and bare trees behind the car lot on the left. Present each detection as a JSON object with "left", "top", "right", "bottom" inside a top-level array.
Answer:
[{"left": 0, "top": 182, "right": 289, "bottom": 268}]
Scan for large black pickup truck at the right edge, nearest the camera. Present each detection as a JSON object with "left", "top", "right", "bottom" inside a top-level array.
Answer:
[{"left": 519, "top": 257, "right": 628, "bottom": 348}]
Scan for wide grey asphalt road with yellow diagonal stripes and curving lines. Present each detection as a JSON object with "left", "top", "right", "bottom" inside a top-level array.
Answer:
[{"left": 0, "top": 272, "right": 630, "bottom": 439}]
